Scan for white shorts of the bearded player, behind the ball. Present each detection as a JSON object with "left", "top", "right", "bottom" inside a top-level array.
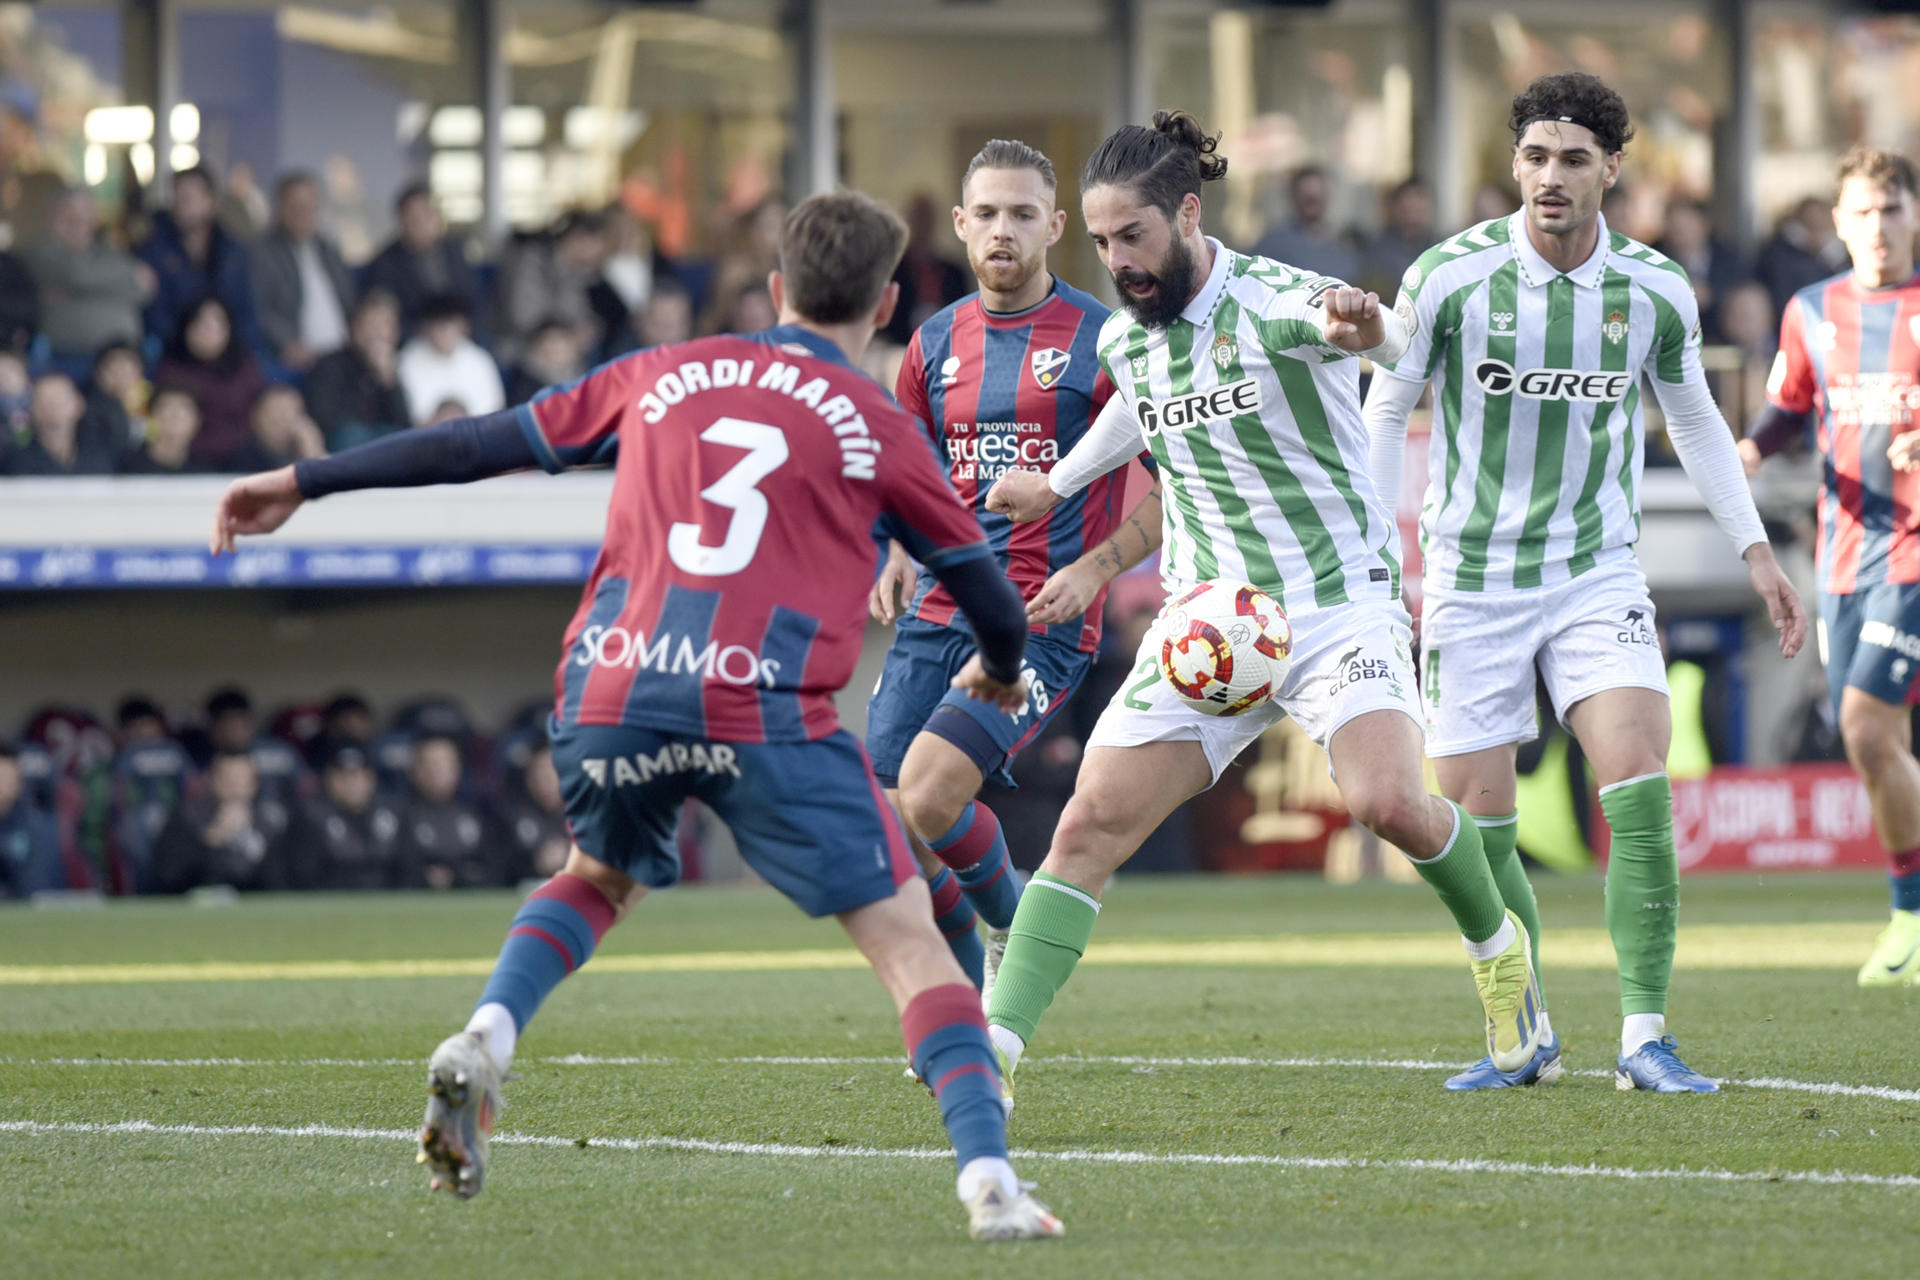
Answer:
[{"left": 1087, "top": 601, "right": 1421, "bottom": 783}]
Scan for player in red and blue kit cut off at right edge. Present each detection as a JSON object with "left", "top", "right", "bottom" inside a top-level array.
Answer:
[{"left": 1740, "top": 148, "right": 1920, "bottom": 986}]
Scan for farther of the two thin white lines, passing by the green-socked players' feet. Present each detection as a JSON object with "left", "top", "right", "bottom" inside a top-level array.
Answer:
[{"left": 15, "top": 1054, "right": 1920, "bottom": 1102}]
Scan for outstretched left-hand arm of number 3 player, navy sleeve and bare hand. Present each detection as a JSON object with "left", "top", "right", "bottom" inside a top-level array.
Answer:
[{"left": 209, "top": 409, "right": 540, "bottom": 555}]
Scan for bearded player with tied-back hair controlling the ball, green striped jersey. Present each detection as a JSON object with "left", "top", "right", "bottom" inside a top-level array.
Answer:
[{"left": 987, "top": 111, "right": 1540, "bottom": 1105}]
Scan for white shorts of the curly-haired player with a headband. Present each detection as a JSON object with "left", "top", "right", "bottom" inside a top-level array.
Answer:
[{"left": 1421, "top": 557, "right": 1667, "bottom": 758}]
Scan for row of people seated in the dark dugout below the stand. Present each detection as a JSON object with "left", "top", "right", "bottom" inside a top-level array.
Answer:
[{"left": 0, "top": 689, "right": 583, "bottom": 898}]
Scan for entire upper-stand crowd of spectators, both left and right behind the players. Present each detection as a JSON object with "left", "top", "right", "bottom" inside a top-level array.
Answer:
[{"left": 0, "top": 152, "right": 1847, "bottom": 485}]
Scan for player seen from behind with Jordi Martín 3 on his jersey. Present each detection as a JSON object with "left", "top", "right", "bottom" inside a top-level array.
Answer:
[{"left": 213, "top": 192, "right": 1062, "bottom": 1240}]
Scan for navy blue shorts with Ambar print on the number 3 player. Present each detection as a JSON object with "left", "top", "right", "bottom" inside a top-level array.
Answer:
[{"left": 553, "top": 725, "right": 920, "bottom": 915}]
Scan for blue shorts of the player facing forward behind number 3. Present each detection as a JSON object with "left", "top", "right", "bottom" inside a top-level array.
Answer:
[{"left": 866, "top": 620, "right": 1092, "bottom": 789}]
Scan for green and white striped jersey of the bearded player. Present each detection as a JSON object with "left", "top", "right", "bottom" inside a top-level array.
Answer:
[{"left": 1100, "top": 240, "right": 1400, "bottom": 616}]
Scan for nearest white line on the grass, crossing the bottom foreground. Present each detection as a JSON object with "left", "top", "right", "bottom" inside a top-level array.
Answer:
[{"left": 0, "top": 1121, "right": 1920, "bottom": 1190}]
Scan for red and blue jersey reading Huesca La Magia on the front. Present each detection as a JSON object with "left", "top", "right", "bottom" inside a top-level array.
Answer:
[{"left": 895, "top": 278, "right": 1125, "bottom": 652}]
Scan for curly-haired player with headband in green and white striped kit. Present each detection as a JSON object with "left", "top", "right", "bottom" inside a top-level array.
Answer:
[{"left": 1365, "top": 73, "right": 1807, "bottom": 1092}]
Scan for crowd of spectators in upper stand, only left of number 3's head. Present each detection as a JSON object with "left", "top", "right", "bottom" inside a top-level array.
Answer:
[{"left": 0, "top": 167, "right": 833, "bottom": 476}]
